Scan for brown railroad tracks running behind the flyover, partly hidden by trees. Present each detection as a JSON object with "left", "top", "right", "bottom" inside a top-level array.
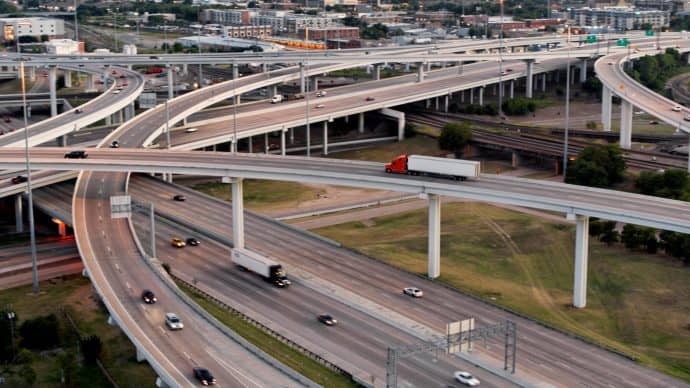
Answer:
[{"left": 407, "top": 113, "right": 687, "bottom": 170}]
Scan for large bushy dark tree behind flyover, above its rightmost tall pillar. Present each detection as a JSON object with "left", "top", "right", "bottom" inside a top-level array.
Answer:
[{"left": 565, "top": 145, "right": 626, "bottom": 187}]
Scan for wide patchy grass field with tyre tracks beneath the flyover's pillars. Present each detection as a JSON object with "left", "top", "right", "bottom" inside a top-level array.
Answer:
[{"left": 313, "top": 203, "right": 690, "bottom": 381}]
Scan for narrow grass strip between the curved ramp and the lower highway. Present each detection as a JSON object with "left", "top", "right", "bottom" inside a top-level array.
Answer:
[{"left": 178, "top": 283, "right": 358, "bottom": 388}]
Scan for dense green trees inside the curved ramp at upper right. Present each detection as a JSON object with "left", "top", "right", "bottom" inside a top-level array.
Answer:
[{"left": 628, "top": 48, "right": 684, "bottom": 92}]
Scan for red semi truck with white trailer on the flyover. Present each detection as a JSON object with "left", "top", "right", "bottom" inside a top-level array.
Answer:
[{"left": 385, "top": 155, "right": 481, "bottom": 181}]
